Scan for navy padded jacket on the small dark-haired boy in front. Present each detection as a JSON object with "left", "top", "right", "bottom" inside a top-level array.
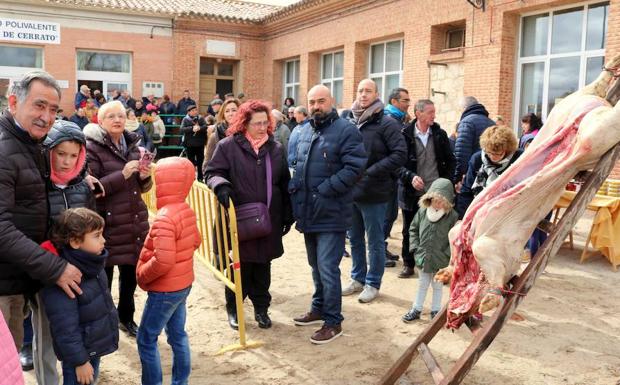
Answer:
[{"left": 41, "top": 247, "right": 118, "bottom": 367}]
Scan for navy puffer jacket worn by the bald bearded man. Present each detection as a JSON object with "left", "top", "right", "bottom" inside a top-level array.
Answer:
[{"left": 288, "top": 110, "right": 366, "bottom": 233}]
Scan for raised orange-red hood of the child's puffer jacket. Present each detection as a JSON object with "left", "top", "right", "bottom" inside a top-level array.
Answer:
[{"left": 155, "top": 156, "right": 196, "bottom": 209}]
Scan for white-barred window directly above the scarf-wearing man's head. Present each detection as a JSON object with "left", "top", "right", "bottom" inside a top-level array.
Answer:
[{"left": 368, "top": 40, "right": 403, "bottom": 100}]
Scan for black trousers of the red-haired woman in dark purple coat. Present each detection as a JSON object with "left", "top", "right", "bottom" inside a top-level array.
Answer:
[{"left": 225, "top": 262, "right": 271, "bottom": 313}]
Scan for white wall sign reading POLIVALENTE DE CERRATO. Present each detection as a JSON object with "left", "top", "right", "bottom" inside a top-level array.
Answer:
[{"left": 0, "top": 18, "right": 60, "bottom": 44}]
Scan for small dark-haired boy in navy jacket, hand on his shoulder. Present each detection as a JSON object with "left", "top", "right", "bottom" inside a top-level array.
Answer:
[{"left": 41, "top": 208, "right": 118, "bottom": 385}]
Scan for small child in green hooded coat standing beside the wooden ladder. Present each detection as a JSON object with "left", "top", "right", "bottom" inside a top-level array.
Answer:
[{"left": 402, "top": 178, "right": 458, "bottom": 322}]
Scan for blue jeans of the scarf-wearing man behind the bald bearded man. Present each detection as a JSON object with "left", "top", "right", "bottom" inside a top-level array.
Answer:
[{"left": 350, "top": 202, "right": 387, "bottom": 289}]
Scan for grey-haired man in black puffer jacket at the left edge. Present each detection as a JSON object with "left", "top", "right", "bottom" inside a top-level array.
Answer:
[{"left": 0, "top": 71, "right": 81, "bottom": 356}]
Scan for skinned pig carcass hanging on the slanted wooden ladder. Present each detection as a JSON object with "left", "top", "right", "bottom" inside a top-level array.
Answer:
[{"left": 440, "top": 56, "right": 620, "bottom": 328}]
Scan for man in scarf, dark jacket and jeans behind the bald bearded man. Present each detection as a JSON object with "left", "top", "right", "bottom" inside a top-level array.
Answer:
[{"left": 342, "top": 79, "right": 407, "bottom": 303}]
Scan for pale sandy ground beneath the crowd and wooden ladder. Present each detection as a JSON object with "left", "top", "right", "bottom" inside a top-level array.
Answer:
[{"left": 26, "top": 213, "right": 620, "bottom": 385}]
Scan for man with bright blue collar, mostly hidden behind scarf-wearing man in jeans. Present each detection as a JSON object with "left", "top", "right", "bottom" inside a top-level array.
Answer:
[{"left": 383, "top": 87, "right": 411, "bottom": 267}]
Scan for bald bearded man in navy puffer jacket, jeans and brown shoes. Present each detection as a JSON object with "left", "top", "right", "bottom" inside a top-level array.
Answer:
[{"left": 288, "top": 85, "right": 366, "bottom": 344}]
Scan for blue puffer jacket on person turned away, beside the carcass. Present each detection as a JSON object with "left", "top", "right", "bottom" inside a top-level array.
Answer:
[{"left": 453, "top": 104, "right": 495, "bottom": 183}]
